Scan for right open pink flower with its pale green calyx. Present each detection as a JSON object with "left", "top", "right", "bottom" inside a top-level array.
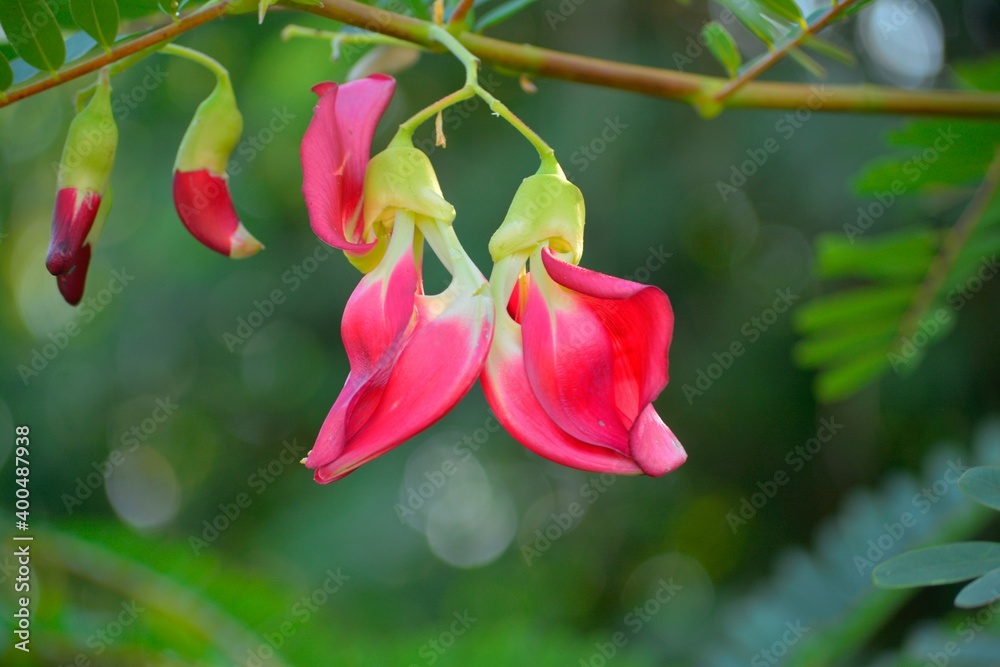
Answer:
[{"left": 482, "top": 174, "right": 687, "bottom": 476}]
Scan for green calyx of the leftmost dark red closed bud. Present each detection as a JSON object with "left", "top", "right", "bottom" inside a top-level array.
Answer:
[{"left": 58, "top": 69, "right": 118, "bottom": 193}]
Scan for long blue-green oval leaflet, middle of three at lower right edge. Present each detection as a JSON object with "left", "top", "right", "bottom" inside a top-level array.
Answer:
[{"left": 872, "top": 542, "right": 1000, "bottom": 588}]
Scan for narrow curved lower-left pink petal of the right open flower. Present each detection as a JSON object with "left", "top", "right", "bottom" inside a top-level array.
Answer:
[{"left": 480, "top": 318, "right": 643, "bottom": 475}]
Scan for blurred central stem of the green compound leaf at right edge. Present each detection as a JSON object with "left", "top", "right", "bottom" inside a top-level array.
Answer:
[{"left": 894, "top": 151, "right": 1000, "bottom": 347}]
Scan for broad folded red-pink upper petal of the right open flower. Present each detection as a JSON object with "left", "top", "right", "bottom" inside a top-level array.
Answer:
[{"left": 523, "top": 249, "right": 673, "bottom": 454}]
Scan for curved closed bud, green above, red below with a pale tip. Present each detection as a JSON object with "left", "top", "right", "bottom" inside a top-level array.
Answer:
[{"left": 174, "top": 70, "right": 264, "bottom": 259}]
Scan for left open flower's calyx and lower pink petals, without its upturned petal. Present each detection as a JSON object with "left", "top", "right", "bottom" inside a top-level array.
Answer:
[{"left": 305, "top": 146, "right": 494, "bottom": 483}]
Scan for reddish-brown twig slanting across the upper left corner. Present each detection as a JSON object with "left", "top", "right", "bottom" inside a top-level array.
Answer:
[{"left": 0, "top": 0, "right": 231, "bottom": 107}]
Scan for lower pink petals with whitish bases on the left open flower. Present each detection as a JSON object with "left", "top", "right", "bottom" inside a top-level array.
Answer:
[{"left": 306, "top": 221, "right": 493, "bottom": 483}]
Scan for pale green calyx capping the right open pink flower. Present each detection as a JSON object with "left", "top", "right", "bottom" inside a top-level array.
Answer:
[{"left": 490, "top": 173, "right": 585, "bottom": 264}]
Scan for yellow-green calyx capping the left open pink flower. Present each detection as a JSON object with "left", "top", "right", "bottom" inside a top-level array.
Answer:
[{"left": 364, "top": 141, "right": 455, "bottom": 238}]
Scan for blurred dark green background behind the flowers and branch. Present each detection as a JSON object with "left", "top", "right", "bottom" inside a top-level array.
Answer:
[{"left": 0, "top": 0, "right": 1000, "bottom": 667}]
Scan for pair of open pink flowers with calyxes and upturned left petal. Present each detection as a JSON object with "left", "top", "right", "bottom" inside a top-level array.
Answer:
[{"left": 302, "top": 74, "right": 687, "bottom": 483}]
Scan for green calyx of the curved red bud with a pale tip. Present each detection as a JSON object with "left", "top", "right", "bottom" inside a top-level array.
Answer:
[{"left": 174, "top": 74, "right": 243, "bottom": 176}]
